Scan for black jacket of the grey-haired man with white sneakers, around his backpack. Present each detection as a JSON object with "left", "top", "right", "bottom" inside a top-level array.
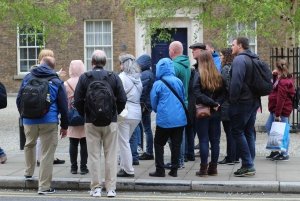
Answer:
[{"left": 74, "top": 66, "right": 127, "bottom": 123}]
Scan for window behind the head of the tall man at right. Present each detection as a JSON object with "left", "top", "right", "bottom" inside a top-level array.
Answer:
[{"left": 228, "top": 22, "right": 257, "bottom": 53}]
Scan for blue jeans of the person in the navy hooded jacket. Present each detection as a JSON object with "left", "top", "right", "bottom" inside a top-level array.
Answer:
[{"left": 142, "top": 108, "right": 153, "bottom": 155}]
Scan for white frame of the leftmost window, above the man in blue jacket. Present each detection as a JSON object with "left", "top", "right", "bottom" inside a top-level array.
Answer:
[{"left": 17, "top": 27, "right": 45, "bottom": 75}]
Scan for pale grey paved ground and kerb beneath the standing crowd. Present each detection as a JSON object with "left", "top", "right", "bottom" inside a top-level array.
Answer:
[{"left": 0, "top": 96, "right": 300, "bottom": 193}]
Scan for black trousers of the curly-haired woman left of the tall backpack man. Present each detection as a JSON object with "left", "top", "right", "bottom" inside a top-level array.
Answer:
[{"left": 222, "top": 121, "right": 239, "bottom": 161}]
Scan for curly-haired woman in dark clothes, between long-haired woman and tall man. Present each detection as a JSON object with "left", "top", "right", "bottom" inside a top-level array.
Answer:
[{"left": 218, "top": 48, "right": 239, "bottom": 165}]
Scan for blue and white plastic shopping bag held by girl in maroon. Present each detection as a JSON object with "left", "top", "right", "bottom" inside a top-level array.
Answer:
[{"left": 266, "top": 122, "right": 290, "bottom": 152}]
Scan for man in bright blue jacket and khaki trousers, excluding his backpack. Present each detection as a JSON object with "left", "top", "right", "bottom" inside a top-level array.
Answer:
[{"left": 17, "top": 56, "right": 69, "bottom": 194}]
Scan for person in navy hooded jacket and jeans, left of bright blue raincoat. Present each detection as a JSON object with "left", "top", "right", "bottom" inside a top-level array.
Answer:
[{"left": 136, "top": 54, "right": 155, "bottom": 160}]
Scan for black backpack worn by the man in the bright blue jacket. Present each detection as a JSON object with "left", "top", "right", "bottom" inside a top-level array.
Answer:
[{"left": 18, "top": 75, "right": 58, "bottom": 119}]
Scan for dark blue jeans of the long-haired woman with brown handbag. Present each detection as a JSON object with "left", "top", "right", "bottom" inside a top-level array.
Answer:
[{"left": 196, "top": 116, "right": 221, "bottom": 165}]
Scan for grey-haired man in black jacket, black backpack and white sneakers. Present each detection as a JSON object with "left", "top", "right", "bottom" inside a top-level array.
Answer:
[{"left": 74, "top": 50, "right": 127, "bottom": 197}]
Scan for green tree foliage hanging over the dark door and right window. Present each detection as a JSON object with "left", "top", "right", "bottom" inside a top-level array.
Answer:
[{"left": 121, "top": 0, "right": 300, "bottom": 47}]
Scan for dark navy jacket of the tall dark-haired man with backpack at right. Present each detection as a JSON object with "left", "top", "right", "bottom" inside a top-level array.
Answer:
[{"left": 229, "top": 50, "right": 259, "bottom": 104}]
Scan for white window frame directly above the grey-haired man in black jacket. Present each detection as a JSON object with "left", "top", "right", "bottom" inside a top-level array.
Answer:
[{"left": 84, "top": 19, "right": 113, "bottom": 71}]
